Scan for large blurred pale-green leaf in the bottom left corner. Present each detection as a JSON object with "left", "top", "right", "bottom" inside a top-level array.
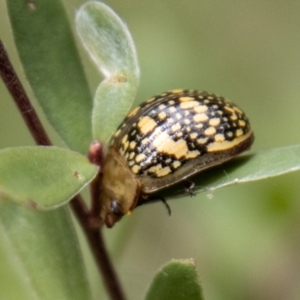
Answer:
[{"left": 0, "top": 200, "right": 92, "bottom": 300}]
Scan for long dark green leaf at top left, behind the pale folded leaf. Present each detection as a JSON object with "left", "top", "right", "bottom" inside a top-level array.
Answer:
[{"left": 6, "top": 0, "right": 92, "bottom": 154}]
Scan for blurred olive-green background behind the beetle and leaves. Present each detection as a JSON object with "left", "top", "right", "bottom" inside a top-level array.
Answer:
[{"left": 0, "top": 0, "right": 300, "bottom": 300}]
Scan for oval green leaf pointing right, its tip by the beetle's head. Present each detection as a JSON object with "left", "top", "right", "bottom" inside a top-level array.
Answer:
[{"left": 0, "top": 146, "right": 97, "bottom": 209}]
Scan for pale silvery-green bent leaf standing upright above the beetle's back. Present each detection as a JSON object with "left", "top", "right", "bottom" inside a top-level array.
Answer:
[{"left": 76, "top": 1, "right": 139, "bottom": 142}]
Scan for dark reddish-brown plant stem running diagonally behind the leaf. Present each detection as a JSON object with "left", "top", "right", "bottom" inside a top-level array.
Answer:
[{"left": 0, "top": 40, "right": 125, "bottom": 300}]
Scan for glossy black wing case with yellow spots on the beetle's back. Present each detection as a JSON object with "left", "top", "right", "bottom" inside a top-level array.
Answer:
[{"left": 111, "top": 90, "right": 252, "bottom": 178}]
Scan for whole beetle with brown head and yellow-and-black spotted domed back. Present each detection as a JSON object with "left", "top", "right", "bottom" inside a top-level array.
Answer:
[{"left": 101, "top": 90, "right": 254, "bottom": 227}]
